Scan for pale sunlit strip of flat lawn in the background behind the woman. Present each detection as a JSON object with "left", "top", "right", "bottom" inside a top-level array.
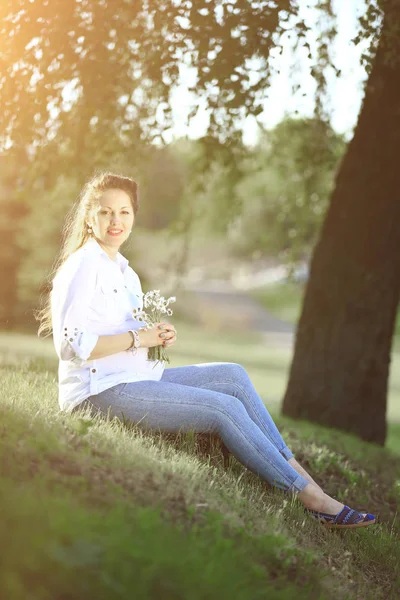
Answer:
[{"left": 0, "top": 321, "right": 400, "bottom": 454}]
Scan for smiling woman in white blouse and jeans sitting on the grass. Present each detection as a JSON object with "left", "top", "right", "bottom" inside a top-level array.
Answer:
[{"left": 39, "top": 172, "right": 375, "bottom": 527}]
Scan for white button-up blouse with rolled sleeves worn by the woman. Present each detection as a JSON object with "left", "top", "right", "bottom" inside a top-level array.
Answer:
[{"left": 51, "top": 238, "right": 165, "bottom": 412}]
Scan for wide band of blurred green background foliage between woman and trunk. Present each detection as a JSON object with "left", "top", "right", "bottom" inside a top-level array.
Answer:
[{"left": 158, "top": 118, "right": 346, "bottom": 272}]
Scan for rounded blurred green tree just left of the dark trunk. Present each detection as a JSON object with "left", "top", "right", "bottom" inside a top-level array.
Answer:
[{"left": 231, "top": 118, "right": 345, "bottom": 261}]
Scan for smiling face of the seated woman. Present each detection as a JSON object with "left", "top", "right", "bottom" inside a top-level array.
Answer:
[{"left": 88, "top": 189, "right": 135, "bottom": 254}]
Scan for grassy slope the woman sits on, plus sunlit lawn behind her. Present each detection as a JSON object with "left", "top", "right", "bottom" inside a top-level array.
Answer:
[{"left": 0, "top": 324, "right": 400, "bottom": 600}]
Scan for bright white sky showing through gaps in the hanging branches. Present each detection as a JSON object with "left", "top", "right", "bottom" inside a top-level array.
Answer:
[{"left": 165, "top": 0, "right": 366, "bottom": 145}]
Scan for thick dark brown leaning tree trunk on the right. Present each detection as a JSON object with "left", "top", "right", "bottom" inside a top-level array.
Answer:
[{"left": 283, "top": 10, "right": 400, "bottom": 445}]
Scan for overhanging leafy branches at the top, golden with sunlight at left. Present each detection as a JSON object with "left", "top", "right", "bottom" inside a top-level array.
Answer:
[{"left": 0, "top": 0, "right": 376, "bottom": 156}]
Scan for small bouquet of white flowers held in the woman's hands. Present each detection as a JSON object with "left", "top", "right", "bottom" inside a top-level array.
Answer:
[{"left": 133, "top": 290, "right": 176, "bottom": 366}]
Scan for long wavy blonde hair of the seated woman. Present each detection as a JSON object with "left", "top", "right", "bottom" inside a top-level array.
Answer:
[{"left": 35, "top": 171, "right": 139, "bottom": 337}]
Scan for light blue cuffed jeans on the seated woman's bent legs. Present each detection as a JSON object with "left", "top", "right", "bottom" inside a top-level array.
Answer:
[{"left": 74, "top": 362, "right": 309, "bottom": 493}]
